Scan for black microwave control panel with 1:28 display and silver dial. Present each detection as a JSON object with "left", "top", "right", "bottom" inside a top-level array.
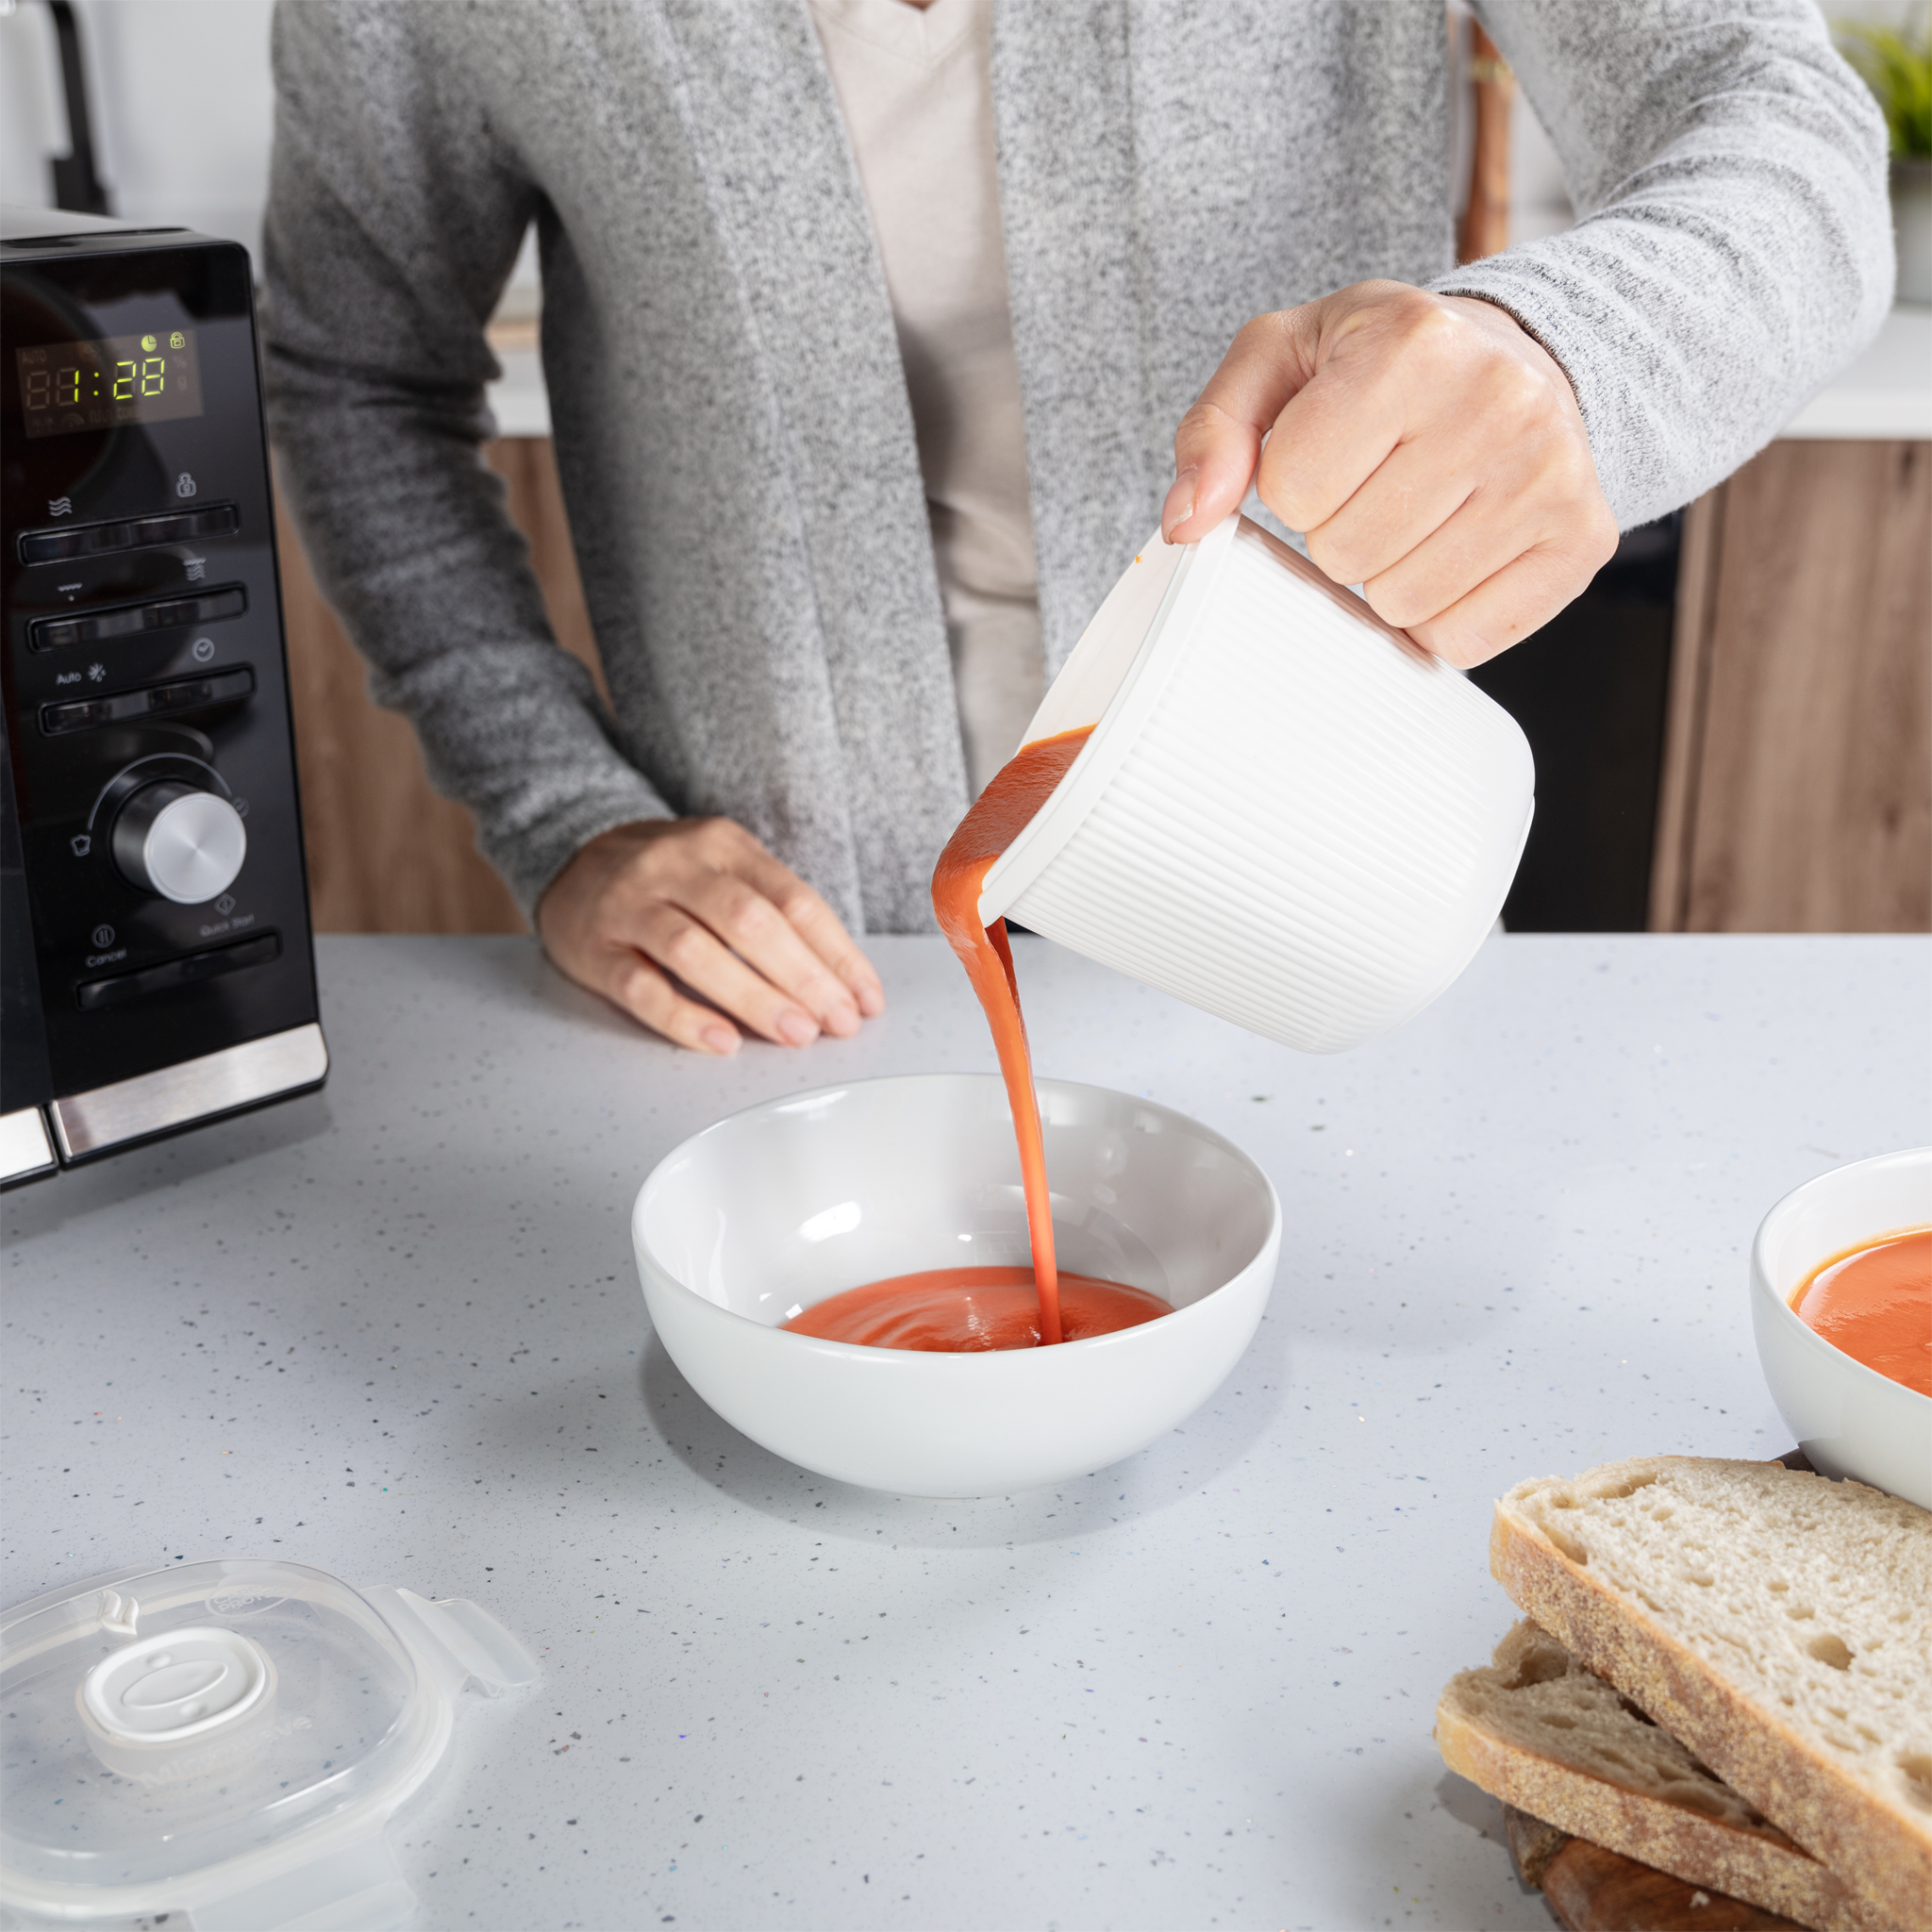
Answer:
[{"left": 0, "top": 234, "right": 317, "bottom": 1113}]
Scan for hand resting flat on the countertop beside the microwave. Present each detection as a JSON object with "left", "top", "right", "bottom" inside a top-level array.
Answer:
[{"left": 537, "top": 819, "right": 885, "bottom": 1053}]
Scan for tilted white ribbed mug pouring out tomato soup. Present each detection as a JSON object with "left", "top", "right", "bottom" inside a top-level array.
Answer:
[{"left": 979, "top": 516, "right": 1536, "bottom": 1053}]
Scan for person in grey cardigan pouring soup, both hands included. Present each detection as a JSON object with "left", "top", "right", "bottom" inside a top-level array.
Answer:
[{"left": 265, "top": 0, "right": 1891, "bottom": 1053}]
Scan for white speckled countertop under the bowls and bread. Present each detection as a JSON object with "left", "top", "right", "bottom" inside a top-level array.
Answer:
[{"left": 0, "top": 937, "right": 1932, "bottom": 1932}]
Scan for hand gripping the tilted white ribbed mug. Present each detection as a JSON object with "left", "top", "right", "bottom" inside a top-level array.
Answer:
[{"left": 1161, "top": 282, "right": 1617, "bottom": 667}]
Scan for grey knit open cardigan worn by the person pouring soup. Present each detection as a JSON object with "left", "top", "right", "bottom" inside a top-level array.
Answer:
[{"left": 267, "top": 0, "right": 1891, "bottom": 931}]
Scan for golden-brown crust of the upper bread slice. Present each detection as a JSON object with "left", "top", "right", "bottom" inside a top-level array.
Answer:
[{"left": 1490, "top": 1457, "right": 1932, "bottom": 1928}]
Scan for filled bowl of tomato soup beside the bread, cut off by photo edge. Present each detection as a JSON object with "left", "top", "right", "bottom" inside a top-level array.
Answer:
[{"left": 1750, "top": 1148, "right": 1932, "bottom": 1508}]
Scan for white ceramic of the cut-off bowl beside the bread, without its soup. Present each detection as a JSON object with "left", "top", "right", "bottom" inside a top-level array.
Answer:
[{"left": 1750, "top": 1148, "right": 1932, "bottom": 1508}]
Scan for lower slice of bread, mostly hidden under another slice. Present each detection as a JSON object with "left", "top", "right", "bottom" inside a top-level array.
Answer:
[{"left": 1436, "top": 1619, "right": 1886, "bottom": 1932}]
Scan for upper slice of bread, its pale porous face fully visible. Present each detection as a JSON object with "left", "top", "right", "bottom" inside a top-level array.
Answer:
[{"left": 1490, "top": 1457, "right": 1932, "bottom": 1928}]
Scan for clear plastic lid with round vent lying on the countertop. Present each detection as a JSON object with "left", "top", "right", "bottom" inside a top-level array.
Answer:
[{"left": 0, "top": 1559, "right": 537, "bottom": 1932}]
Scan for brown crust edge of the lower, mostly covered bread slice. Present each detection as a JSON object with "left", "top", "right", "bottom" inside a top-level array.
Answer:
[{"left": 1436, "top": 1685, "right": 1891, "bottom": 1932}]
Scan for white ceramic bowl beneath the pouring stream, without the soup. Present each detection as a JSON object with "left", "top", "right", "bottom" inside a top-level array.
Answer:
[{"left": 630, "top": 1074, "right": 1281, "bottom": 1495}]
